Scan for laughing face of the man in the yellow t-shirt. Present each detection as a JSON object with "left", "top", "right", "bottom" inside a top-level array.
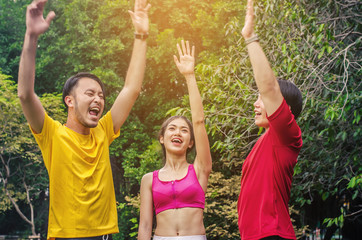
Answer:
[{"left": 65, "top": 77, "right": 104, "bottom": 128}]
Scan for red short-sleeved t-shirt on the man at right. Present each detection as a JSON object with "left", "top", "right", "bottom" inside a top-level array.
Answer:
[{"left": 238, "top": 100, "right": 302, "bottom": 240}]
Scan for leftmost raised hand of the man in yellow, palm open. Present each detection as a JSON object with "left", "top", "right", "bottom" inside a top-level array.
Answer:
[{"left": 26, "top": 0, "right": 55, "bottom": 36}]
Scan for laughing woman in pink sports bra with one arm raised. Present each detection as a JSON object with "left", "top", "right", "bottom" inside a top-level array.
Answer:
[{"left": 138, "top": 40, "right": 212, "bottom": 240}]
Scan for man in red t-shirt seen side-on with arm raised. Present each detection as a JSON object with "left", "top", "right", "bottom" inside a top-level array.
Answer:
[{"left": 238, "top": 0, "right": 302, "bottom": 240}]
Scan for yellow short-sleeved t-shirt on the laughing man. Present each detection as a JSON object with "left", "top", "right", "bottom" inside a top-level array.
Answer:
[{"left": 32, "top": 112, "right": 119, "bottom": 239}]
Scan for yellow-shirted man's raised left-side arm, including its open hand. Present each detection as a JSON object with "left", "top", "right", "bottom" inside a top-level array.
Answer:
[{"left": 18, "top": 0, "right": 55, "bottom": 133}]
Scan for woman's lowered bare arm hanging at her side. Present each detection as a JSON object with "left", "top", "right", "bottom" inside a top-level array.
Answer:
[{"left": 137, "top": 172, "right": 153, "bottom": 240}]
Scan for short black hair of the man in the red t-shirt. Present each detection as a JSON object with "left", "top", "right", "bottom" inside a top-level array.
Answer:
[{"left": 278, "top": 79, "right": 303, "bottom": 119}]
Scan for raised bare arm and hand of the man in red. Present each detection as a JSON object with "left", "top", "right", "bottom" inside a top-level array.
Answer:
[{"left": 241, "top": 0, "right": 283, "bottom": 116}]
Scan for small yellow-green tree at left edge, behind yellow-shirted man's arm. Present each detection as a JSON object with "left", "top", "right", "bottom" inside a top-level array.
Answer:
[{"left": 0, "top": 73, "right": 65, "bottom": 235}]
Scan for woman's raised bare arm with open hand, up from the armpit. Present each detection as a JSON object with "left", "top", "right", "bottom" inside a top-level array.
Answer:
[{"left": 174, "top": 40, "right": 212, "bottom": 190}]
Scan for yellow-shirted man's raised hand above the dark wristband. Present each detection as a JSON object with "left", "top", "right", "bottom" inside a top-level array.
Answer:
[{"left": 128, "top": 0, "right": 151, "bottom": 34}]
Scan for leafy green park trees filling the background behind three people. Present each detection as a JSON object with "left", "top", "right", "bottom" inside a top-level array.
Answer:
[{"left": 0, "top": 0, "right": 362, "bottom": 240}]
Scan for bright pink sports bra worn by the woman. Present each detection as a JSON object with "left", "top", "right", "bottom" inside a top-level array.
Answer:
[{"left": 152, "top": 164, "right": 205, "bottom": 214}]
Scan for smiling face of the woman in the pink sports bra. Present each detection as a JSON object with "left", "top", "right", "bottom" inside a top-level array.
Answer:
[{"left": 159, "top": 118, "right": 193, "bottom": 156}]
